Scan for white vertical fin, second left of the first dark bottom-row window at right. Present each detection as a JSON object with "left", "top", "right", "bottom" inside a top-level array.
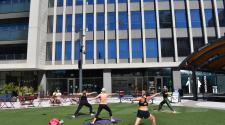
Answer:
[{"left": 141, "top": 0, "right": 146, "bottom": 63}]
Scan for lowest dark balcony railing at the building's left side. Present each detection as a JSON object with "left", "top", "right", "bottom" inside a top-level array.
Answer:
[{"left": 0, "top": 54, "right": 27, "bottom": 61}]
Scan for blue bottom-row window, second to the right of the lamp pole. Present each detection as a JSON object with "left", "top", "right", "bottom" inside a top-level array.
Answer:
[{"left": 96, "top": 40, "right": 105, "bottom": 59}]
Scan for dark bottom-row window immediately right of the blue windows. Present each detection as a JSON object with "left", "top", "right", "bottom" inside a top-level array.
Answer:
[{"left": 161, "top": 38, "right": 174, "bottom": 57}]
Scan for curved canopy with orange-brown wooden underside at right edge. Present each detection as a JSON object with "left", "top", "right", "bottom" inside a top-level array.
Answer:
[{"left": 179, "top": 38, "right": 225, "bottom": 72}]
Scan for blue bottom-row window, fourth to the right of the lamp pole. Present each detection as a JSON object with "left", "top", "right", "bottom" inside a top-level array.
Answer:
[{"left": 119, "top": 39, "right": 129, "bottom": 59}]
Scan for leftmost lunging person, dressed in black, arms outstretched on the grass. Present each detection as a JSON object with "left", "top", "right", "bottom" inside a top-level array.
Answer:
[{"left": 72, "top": 90, "right": 96, "bottom": 118}]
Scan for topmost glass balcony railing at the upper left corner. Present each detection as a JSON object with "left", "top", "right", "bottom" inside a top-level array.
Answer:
[{"left": 0, "top": 0, "right": 30, "bottom": 13}]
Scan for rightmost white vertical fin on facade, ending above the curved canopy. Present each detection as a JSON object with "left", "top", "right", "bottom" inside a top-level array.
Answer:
[{"left": 213, "top": 0, "right": 221, "bottom": 38}]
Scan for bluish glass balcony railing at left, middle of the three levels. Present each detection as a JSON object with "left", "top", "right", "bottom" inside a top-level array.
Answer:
[{"left": 0, "top": 30, "right": 28, "bottom": 41}]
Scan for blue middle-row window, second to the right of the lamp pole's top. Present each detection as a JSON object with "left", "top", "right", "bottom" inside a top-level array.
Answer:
[{"left": 97, "top": 12, "right": 105, "bottom": 31}]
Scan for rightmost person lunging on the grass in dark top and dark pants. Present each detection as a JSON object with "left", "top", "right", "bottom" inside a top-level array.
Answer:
[{"left": 158, "top": 86, "right": 176, "bottom": 113}]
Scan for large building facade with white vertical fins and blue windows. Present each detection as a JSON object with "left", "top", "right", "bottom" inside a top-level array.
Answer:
[{"left": 0, "top": 0, "right": 225, "bottom": 94}]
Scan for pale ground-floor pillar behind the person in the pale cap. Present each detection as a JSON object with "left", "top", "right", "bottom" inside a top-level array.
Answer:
[{"left": 103, "top": 70, "right": 112, "bottom": 93}]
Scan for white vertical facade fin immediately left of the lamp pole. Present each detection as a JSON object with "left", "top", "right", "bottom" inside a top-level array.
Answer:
[{"left": 71, "top": 0, "right": 76, "bottom": 65}]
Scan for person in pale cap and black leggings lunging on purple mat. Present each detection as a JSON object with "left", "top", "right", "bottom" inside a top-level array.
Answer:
[{"left": 91, "top": 88, "right": 115, "bottom": 125}]
